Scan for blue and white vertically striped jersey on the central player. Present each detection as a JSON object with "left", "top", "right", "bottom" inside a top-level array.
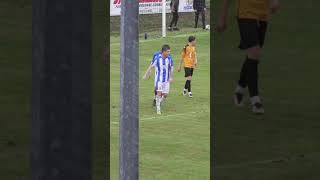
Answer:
[{"left": 151, "top": 52, "right": 173, "bottom": 83}]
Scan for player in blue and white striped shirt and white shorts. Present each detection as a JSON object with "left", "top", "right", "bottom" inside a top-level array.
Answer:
[{"left": 143, "top": 44, "right": 173, "bottom": 114}]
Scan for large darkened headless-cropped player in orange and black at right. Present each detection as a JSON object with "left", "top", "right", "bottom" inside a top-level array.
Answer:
[{"left": 217, "top": 0, "right": 279, "bottom": 114}]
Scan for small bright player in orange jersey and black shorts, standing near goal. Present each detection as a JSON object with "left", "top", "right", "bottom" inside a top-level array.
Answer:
[{"left": 178, "top": 36, "right": 198, "bottom": 98}]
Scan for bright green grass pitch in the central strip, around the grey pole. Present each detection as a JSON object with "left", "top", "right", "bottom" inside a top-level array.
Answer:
[{"left": 110, "top": 31, "right": 210, "bottom": 180}]
